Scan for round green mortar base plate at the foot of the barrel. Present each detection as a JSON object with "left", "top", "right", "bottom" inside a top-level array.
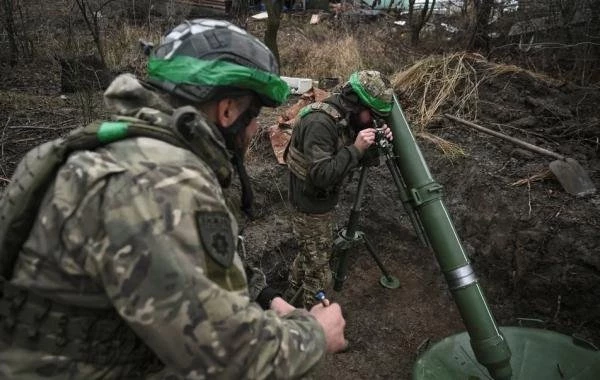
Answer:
[{"left": 413, "top": 327, "right": 600, "bottom": 380}]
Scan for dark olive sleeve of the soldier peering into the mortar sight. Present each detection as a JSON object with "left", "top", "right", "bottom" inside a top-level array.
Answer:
[{"left": 303, "top": 115, "right": 361, "bottom": 188}]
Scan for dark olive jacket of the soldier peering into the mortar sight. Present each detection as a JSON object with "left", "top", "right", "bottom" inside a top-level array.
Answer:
[{"left": 289, "top": 94, "right": 362, "bottom": 213}]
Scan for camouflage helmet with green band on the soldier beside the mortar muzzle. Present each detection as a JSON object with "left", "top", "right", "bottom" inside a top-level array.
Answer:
[{"left": 345, "top": 70, "right": 394, "bottom": 116}]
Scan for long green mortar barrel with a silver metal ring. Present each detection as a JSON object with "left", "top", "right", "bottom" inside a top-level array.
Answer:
[{"left": 388, "top": 97, "right": 512, "bottom": 380}]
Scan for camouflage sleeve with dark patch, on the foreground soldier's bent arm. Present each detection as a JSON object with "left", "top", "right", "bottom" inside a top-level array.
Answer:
[{"left": 86, "top": 166, "right": 325, "bottom": 379}]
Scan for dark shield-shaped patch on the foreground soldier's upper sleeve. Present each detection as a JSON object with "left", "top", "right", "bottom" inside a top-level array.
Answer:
[{"left": 196, "top": 211, "right": 235, "bottom": 268}]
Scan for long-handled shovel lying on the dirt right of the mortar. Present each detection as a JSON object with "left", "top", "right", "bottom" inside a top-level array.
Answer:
[{"left": 444, "top": 114, "right": 596, "bottom": 197}]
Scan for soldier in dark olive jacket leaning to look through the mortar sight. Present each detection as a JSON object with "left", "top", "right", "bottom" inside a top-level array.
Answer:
[{"left": 286, "top": 70, "right": 393, "bottom": 308}]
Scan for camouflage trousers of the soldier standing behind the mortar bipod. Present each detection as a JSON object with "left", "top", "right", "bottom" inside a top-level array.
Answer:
[{"left": 286, "top": 211, "right": 335, "bottom": 309}]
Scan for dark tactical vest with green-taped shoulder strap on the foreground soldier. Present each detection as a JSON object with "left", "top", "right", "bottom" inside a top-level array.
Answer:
[{"left": 0, "top": 109, "right": 218, "bottom": 366}]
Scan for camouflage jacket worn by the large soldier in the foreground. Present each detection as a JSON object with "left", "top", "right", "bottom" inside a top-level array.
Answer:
[{"left": 0, "top": 75, "right": 325, "bottom": 379}]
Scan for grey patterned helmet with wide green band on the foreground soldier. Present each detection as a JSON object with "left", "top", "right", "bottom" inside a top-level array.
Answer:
[{"left": 148, "top": 19, "right": 289, "bottom": 107}]
